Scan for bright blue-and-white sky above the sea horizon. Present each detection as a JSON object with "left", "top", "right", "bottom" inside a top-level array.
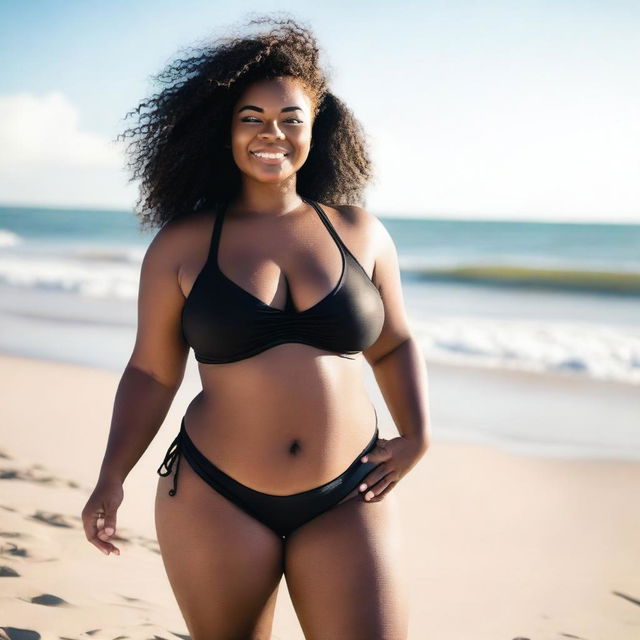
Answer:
[{"left": 0, "top": 0, "right": 640, "bottom": 222}]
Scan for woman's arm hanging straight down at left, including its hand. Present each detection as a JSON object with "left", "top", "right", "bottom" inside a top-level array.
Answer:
[{"left": 82, "top": 218, "right": 189, "bottom": 555}]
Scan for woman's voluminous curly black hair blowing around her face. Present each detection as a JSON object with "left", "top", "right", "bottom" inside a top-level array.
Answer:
[{"left": 116, "top": 15, "right": 373, "bottom": 230}]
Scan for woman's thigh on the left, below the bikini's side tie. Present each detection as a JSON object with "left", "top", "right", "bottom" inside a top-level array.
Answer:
[{"left": 155, "top": 457, "right": 283, "bottom": 640}]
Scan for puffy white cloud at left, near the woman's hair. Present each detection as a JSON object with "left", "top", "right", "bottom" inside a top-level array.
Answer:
[{"left": 0, "top": 91, "right": 122, "bottom": 170}]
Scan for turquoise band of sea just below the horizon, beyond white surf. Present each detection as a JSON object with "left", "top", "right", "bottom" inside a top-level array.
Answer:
[{"left": 0, "top": 207, "right": 640, "bottom": 295}]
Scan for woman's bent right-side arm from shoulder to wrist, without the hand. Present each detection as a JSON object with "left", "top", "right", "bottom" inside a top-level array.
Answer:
[{"left": 364, "top": 216, "right": 431, "bottom": 453}]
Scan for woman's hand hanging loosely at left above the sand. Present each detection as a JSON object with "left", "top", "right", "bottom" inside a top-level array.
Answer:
[{"left": 82, "top": 480, "right": 124, "bottom": 556}]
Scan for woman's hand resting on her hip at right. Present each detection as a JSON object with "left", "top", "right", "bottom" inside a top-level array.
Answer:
[{"left": 358, "top": 436, "right": 426, "bottom": 502}]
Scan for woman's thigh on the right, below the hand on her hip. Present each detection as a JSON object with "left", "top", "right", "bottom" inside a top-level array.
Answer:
[{"left": 284, "top": 491, "right": 408, "bottom": 640}]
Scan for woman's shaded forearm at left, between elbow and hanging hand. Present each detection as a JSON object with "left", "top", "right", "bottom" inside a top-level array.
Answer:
[{"left": 99, "top": 367, "right": 178, "bottom": 482}]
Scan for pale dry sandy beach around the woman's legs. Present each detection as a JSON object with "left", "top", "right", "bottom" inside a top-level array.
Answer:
[{"left": 0, "top": 356, "right": 640, "bottom": 640}]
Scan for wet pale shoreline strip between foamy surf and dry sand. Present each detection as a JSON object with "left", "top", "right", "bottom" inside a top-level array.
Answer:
[{"left": 5, "top": 350, "right": 640, "bottom": 462}]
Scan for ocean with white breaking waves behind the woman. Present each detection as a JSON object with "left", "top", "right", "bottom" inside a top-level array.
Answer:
[{"left": 0, "top": 206, "right": 640, "bottom": 459}]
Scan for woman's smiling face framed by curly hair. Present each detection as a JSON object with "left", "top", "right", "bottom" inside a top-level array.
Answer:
[{"left": 231, "top": 77, "right": 313, "bottom": 183}]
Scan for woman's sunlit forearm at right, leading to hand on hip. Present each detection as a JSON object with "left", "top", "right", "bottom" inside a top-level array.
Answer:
[{"left": 371, "top": 337, "right": 431, "bottom": 451}]
